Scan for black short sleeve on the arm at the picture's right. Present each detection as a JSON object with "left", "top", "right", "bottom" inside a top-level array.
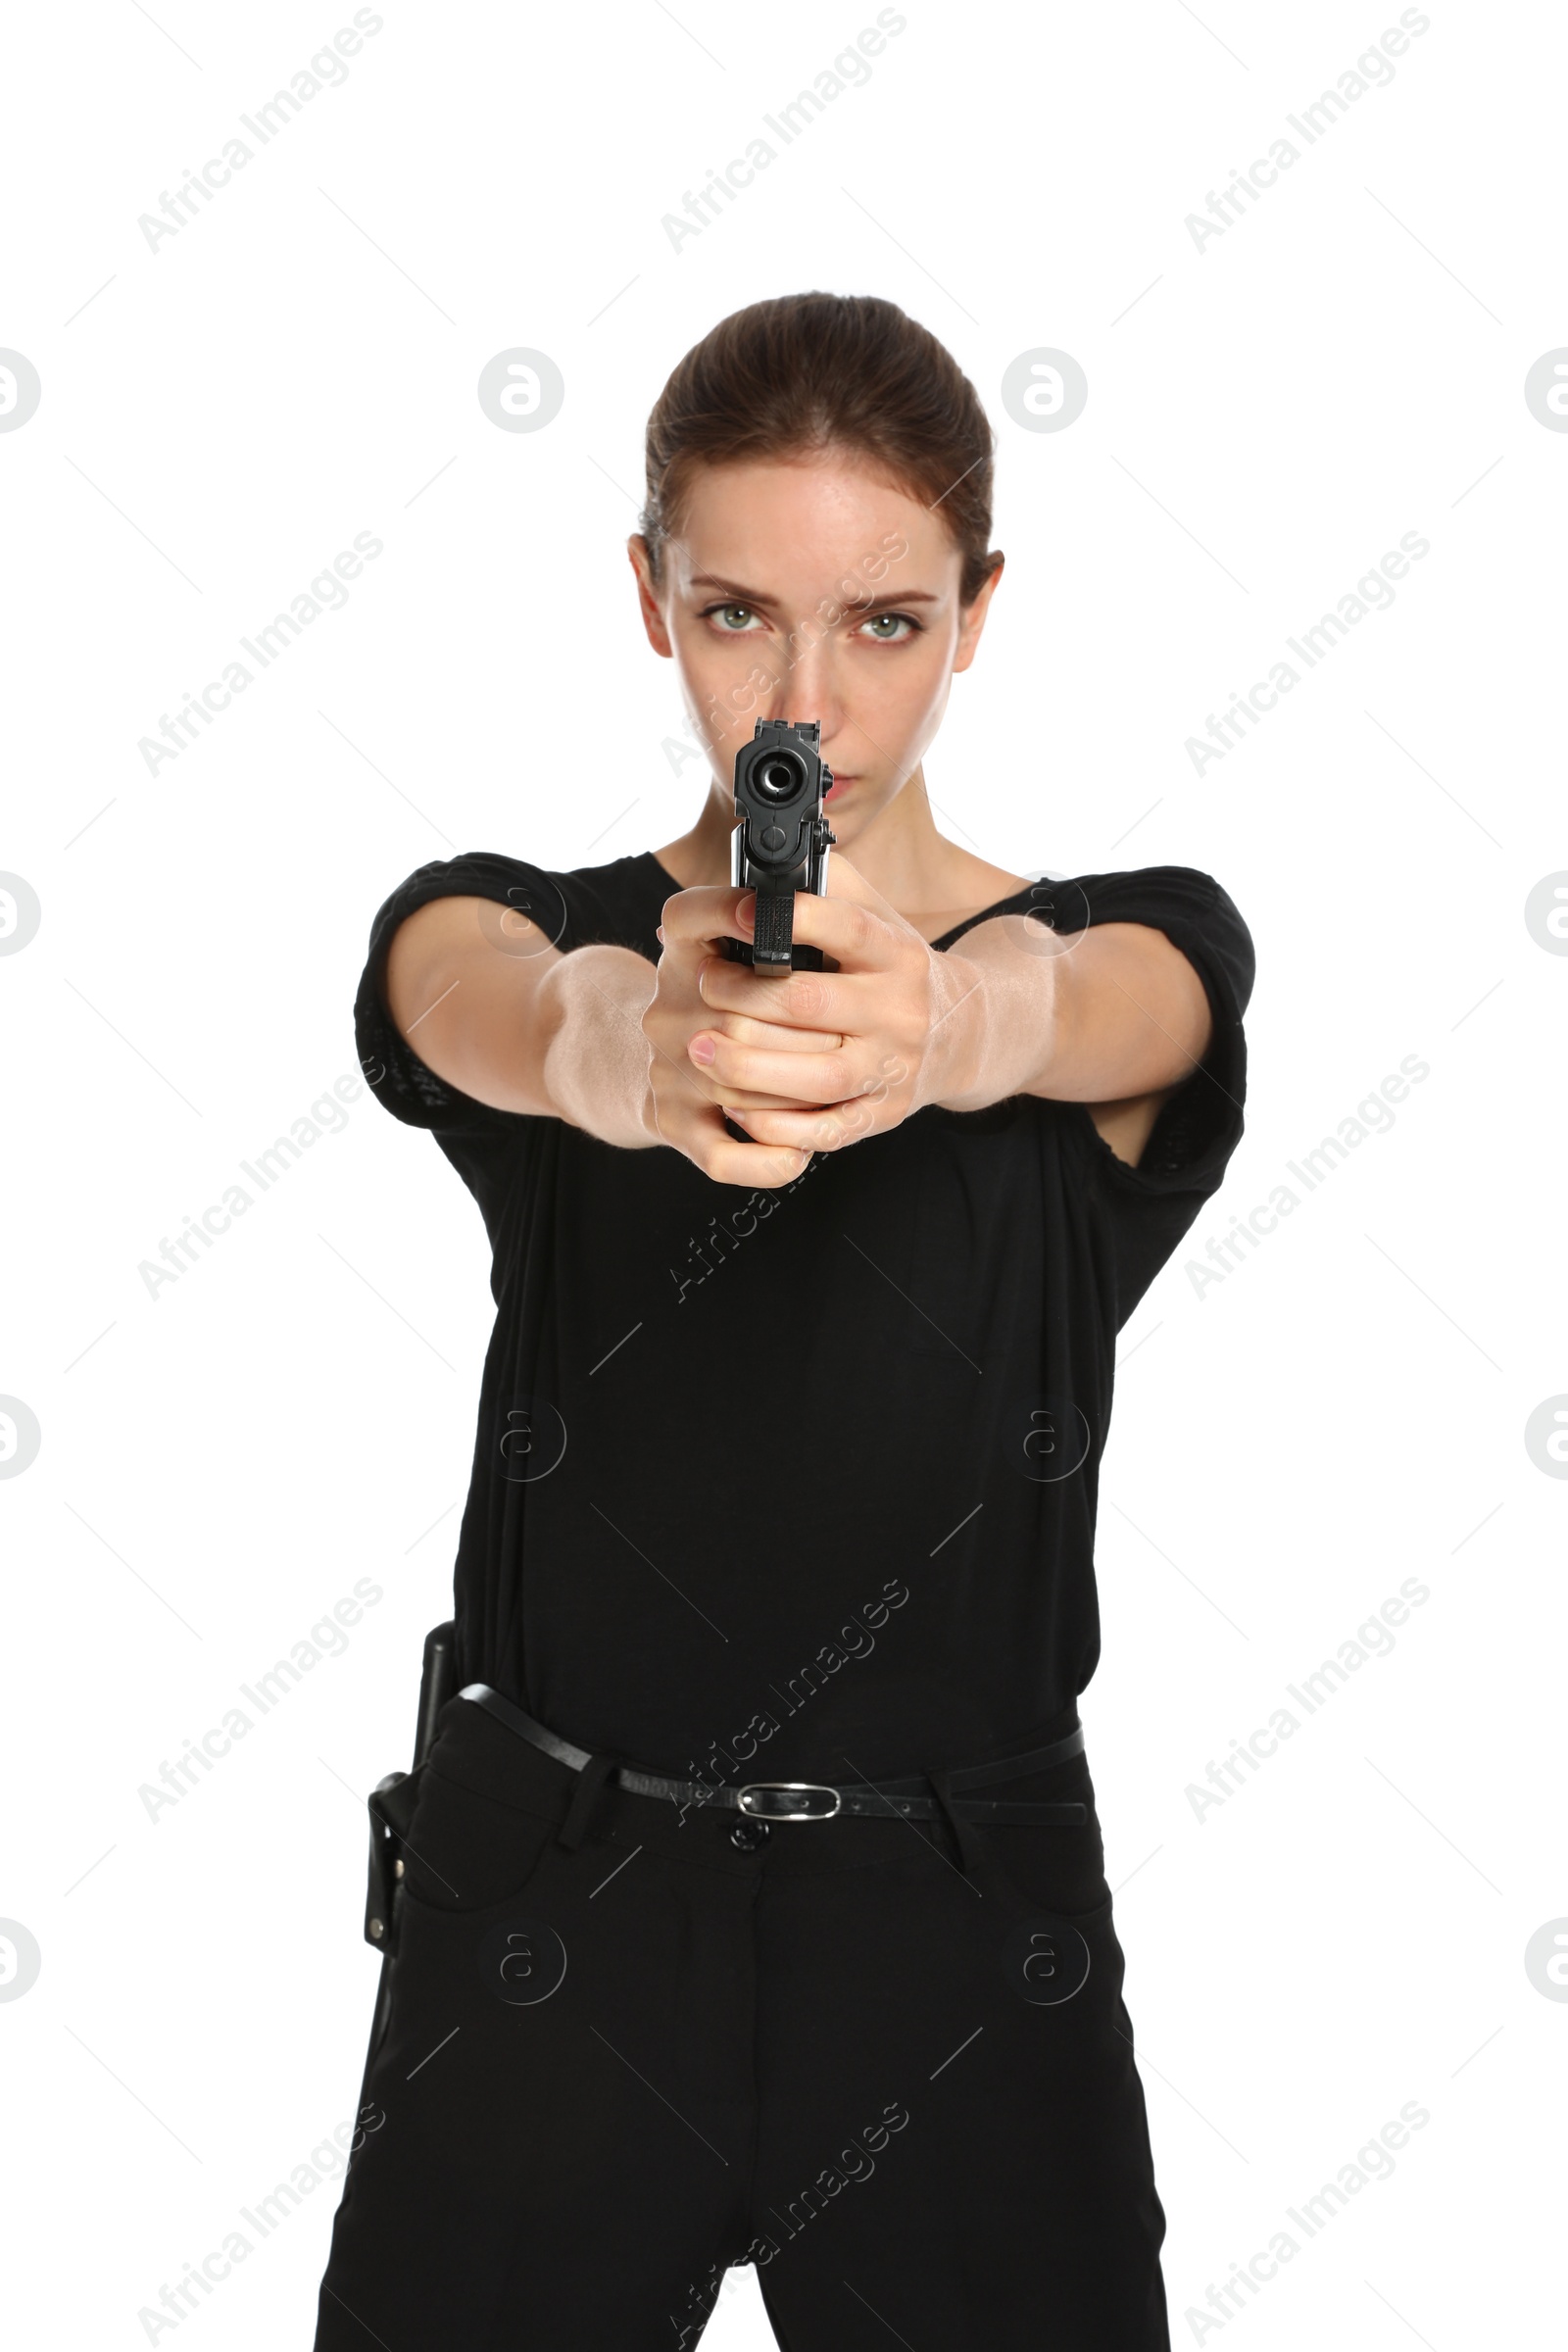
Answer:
[{"left": 1042, "top": 865, "right": 1255, "bottom": 1322}]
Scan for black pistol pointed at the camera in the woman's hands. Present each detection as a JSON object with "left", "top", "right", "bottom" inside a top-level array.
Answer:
[{"left": 721, "top": 719, "right": 837, "bottom": 974}]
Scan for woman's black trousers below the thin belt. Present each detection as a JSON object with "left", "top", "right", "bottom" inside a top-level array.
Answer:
[{"left": 315, "top": 1698, "right": 1171, "bottom": 2352}]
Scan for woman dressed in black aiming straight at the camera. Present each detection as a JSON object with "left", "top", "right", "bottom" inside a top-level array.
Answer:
[{"left": 318, "top": 294, "right": 1253, "bottom": 2352}]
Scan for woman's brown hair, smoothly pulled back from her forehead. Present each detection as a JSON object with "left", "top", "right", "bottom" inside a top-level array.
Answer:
[{"left": 642, "top": 294, "right": 1002, "bottom": 605}]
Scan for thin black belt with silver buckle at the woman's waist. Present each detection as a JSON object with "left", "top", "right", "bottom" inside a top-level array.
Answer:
[{"left": 459, "top": 1682, "right": 1089, "bottom": 1828}]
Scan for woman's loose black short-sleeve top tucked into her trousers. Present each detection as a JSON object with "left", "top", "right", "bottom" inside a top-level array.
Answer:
[{"left": 355, "top": 852, "right": 1253, "bottom": 1781}]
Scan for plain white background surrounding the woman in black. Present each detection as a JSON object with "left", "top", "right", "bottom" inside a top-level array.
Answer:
[{"left": 0, "top": 0, "right": 1568, "bottom": 2352}]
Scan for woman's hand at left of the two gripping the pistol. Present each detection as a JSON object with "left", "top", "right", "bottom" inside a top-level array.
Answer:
[{"left": 642, "top": 868, "right": 859, "bottom": 1188}]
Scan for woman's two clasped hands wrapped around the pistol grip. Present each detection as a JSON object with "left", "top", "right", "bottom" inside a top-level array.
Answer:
[{"left": 662, "top": 854, "right": 983, "bottom": 1181}]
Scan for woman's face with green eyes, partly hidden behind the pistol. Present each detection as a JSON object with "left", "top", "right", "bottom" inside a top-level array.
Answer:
[{"left": 630, "top": 454, "right": 999, "bottom": 847}]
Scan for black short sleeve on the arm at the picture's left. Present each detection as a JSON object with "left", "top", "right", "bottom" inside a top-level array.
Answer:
[{"left": 355, "top": 849, "right": 630, "bottom": 1136}]
